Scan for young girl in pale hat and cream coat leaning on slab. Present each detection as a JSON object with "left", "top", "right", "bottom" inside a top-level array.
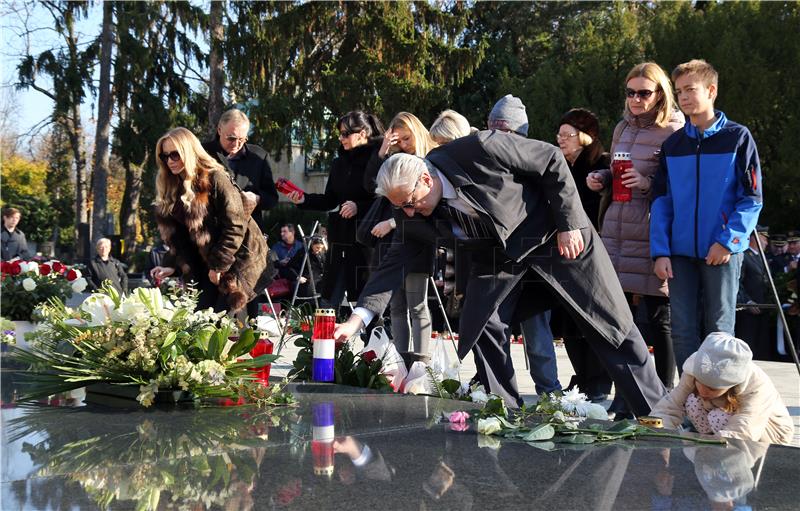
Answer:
[{"left": 650, "top": 332, "right": 794, "bottom": 444}]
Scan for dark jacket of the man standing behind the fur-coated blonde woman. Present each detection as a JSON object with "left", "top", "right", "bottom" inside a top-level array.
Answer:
[{"left": 203, "top": 135, "right": 278, "bottom": 232}]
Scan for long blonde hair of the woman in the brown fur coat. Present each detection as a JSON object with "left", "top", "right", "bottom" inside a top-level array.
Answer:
[{"left": 155, "top": 127, "right": 222, "bottom": 216}]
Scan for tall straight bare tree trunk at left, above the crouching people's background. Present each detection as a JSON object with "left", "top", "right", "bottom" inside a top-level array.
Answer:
[{"left": 92, "top": 2, "right": 114, "bottom": 245}]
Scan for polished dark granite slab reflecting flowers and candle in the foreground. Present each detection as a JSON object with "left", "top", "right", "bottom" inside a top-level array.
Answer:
[{"left": 0, "top": 370, "right": 800, "bottom": 510}]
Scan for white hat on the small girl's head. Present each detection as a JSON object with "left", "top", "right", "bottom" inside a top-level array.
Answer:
[{"left": 683, "top": 332, "right": 753, "bottom": 389}]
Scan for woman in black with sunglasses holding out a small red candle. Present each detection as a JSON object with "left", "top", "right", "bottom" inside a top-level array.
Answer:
[{"left": 289, "top": 110, "right": 383, "bottom": 307}]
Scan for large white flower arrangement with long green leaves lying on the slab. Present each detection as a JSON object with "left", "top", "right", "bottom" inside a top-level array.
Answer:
[{"left": 13, "top": 287, "right": 277, "bottom": 406}]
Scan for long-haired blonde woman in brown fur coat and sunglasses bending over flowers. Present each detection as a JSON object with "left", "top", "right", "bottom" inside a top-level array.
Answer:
[{"left": 150, "top": 128, "right": 271, "bottom": 313}]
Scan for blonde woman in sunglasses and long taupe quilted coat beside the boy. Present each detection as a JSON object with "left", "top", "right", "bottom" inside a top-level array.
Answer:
[{"left": 586, "top": 62, "right": 684, "bottom": 416}]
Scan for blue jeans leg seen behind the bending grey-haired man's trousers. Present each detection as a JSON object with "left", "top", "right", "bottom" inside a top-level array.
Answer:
[{"left": 520, "top": 310, "right": 561, "bottom": 394}]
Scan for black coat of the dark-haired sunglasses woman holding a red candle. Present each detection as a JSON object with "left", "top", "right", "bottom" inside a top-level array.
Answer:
[{"left": 298, "top": 137, "right": 383, "bottom": 299}]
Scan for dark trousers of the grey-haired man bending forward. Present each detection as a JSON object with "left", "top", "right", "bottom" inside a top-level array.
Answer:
[{"left": 473, "top": 272, "right": 666, "bottom": 415}]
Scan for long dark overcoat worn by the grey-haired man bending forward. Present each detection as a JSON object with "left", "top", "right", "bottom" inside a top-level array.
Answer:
[{"left": 359, "top": 131, "right": 633, "bottom": 358}]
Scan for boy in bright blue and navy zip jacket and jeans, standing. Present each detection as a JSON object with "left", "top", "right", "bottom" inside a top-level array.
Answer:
[{"left": 650, "top": 60, "right": 762, "bottom": 372}]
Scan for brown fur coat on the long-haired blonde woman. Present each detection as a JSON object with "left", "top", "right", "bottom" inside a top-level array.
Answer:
[{"left": 156, "top": 170, "right": 271, "bottom": 311}]
